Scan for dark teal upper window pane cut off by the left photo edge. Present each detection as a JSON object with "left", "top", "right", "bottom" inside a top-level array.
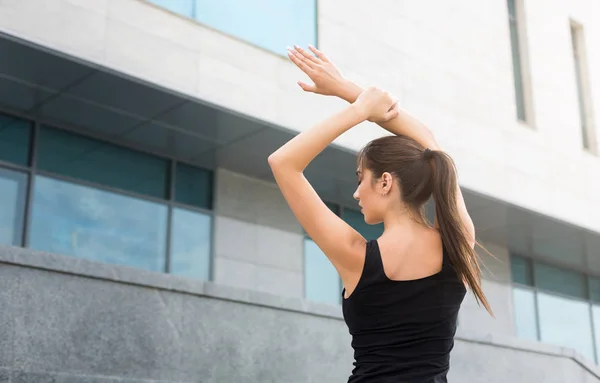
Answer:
[{"left": 0, "top": 114, "right": 32, "bottom": 165}]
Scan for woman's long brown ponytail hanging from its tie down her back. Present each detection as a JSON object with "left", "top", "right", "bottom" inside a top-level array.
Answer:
[{"left": 424, "top": 149, "right": 494, "bottom": 316}]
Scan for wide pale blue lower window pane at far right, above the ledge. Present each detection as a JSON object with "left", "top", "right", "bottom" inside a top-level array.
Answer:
[{"left": 538, "top": 293, "right": 594, "bottom": 360}]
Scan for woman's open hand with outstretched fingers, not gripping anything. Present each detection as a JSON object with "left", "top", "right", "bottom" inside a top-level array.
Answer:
[{"left": 288, "top": 45, "right": 346, "bottom": 97}]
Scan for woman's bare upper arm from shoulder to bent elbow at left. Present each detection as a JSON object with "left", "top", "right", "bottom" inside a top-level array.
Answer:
[{"left": 271, "top": 164, "right": 366, "bottom": 274}]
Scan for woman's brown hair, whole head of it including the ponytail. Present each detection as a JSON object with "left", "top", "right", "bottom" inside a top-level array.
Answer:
[{"left": 358, "top": 136, "right": 494, "bottom": 316}]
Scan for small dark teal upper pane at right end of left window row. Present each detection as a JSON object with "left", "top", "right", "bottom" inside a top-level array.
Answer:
[{"left": 175, "top": 163, "right": 213, "bottom": 209}]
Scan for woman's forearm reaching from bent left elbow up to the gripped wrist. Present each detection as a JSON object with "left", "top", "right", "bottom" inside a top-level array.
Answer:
[{"left": 269, "top": 104, "right": 367, "bottom": 172}]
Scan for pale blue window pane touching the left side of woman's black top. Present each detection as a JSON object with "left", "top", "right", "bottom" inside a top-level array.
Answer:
[{"left": 304, "top": 238, "right": 342, "bottom": 305}]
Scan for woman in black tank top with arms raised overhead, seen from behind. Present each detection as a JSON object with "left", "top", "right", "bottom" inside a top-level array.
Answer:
[{"left": 269, "top": 46, "right": 492, "bottom": 383}]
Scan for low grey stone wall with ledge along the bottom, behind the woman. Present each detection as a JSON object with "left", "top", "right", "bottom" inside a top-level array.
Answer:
[{"left": 0, "top": 247, "right": 600, "bottom": 383}]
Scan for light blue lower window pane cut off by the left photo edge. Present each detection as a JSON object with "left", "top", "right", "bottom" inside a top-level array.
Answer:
[{"left": 0, "top": 168, "right": 27, "bottom": 246}]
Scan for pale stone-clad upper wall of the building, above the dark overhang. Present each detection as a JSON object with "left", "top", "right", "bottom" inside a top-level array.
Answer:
[{"left": 0, "top": 0, "right": 600, "bottom": 231}]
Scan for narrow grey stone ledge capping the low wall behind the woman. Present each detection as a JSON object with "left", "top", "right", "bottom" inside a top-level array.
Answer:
[{"left": 0, "top": 246, "right": 600, "bottom": 382}]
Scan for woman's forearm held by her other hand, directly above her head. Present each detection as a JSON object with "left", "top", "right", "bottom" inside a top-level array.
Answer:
[{"left": 338, "top": 81, "right": 440, "bottom": 150}]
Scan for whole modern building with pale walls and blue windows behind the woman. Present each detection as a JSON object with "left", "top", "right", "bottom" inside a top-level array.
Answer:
[{"left": 0, "top": 0, "right": 600, "bottom": 383}]
